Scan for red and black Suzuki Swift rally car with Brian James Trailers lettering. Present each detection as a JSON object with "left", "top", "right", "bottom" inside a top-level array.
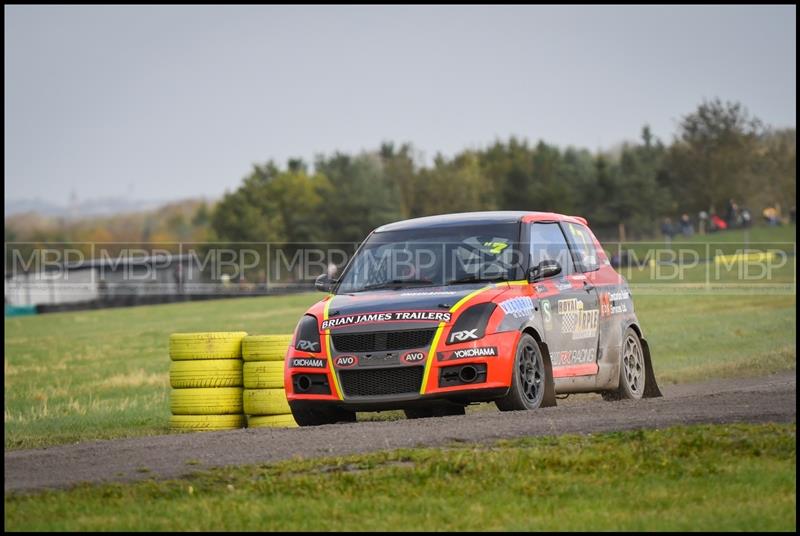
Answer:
[{"left": 284, "top": 212, "right": 660, "bottom": 426}]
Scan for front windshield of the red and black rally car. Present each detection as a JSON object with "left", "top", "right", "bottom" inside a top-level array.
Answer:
[{"left": 337, "top": 223, "right": 523, "bottom": 294}]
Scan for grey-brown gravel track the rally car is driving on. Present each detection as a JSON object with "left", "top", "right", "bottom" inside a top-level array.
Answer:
[{"left": 5, "top": 371, "right": 796, "bottom": 493}]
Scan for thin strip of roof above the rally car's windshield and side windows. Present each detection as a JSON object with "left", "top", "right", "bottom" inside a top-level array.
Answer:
[{"left": 374, "top": 210, "right": 586, "bottom": 233}]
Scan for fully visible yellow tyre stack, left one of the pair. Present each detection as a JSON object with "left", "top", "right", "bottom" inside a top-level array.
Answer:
[{"left": 169, "top": 331, "right": 247, "bottom": 430}]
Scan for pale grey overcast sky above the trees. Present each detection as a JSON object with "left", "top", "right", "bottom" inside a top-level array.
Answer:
[{"left": 5, "top": 6, "right": 797, "bottom": 204}]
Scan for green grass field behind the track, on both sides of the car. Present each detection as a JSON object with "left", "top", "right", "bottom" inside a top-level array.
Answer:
[{"left": 3, "top": 228, "right": 797, "bottom": 449}]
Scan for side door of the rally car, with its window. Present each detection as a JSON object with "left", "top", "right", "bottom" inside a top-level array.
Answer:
[{"left": 529, "top": 222, "right": 599, "bottom": 378}]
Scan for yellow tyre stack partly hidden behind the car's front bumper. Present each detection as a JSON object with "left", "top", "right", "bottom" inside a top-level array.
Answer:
[{"left": 242, "top": 335, "right": 297, "bottom": 428}]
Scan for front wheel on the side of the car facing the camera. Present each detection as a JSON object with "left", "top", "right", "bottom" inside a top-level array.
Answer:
[{"left": 495, "top": 333, "right": 555, "bottom": 411}]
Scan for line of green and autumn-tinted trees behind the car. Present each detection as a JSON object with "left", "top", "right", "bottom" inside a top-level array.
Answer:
[{"left": 210, "top": 99, "right": 796, "bottom": 243}]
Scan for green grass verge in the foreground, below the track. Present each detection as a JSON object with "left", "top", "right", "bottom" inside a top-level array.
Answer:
[{"left": 5, "top": 424, "right": 797, "bottom": 531}]
